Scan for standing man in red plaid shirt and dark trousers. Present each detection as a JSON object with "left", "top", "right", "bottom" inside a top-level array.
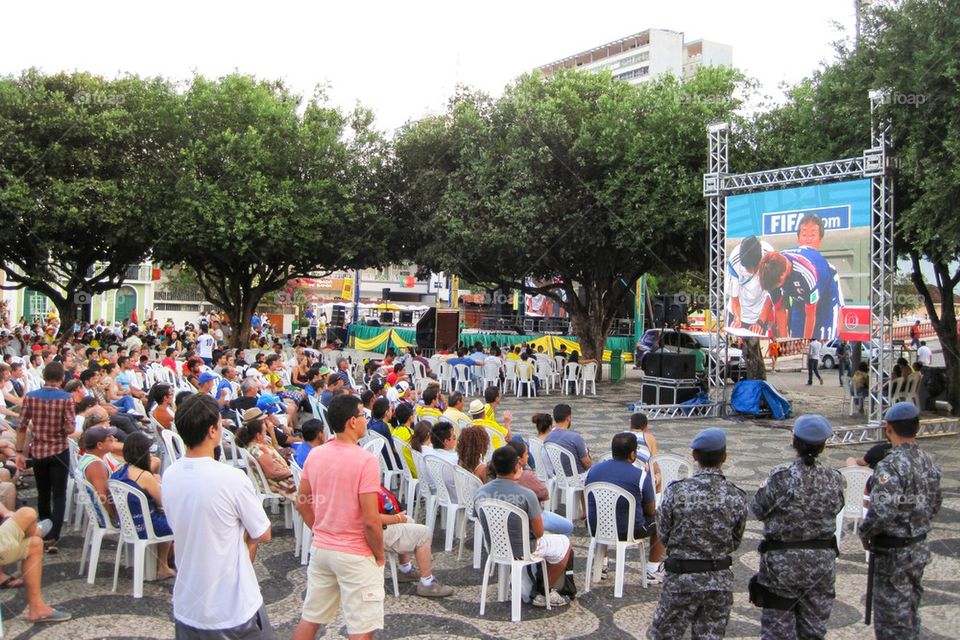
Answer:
[{"left": 16, "top": 362, "right": 75, "bottom": 552}]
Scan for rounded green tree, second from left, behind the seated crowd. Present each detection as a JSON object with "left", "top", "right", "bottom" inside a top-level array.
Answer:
[{"left": 155, "top": 75, "right": 391, "bottom": 347}]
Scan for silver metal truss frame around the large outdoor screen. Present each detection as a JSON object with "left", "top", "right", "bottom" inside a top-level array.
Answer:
[{"left": 703, "top": 91, "right": 896, "bottom": 425}]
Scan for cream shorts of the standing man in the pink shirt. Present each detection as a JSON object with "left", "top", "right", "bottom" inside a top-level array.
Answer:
[{"left": 303, "top": 547, "right": 384, "bottom": 634}]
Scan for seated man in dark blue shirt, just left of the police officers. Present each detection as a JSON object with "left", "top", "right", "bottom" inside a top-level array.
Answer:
[{"left": 586, "top": 432, "right": 664, "bottom": 584}]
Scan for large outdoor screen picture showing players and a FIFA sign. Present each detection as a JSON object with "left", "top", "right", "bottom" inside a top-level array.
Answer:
[{"left": 724, "top": 180, "right": 870, "bottom": 340}]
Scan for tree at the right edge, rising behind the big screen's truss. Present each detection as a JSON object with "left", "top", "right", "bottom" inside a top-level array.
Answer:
[{"left": 738, "top": 0, "right": 960, "bottom": 415}]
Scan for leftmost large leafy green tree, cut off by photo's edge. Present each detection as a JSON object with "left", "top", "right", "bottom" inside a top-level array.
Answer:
[{"left": 0, "top": 70, "right": 177, "bottom": 331}]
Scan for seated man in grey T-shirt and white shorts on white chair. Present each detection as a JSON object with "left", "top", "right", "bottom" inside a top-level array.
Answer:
[{"left": 474, "top": 447, "right": 570, "bottom": 607}]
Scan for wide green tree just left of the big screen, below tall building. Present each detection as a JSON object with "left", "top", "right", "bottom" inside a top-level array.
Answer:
[{"left": 395, "top": 69, "right": 738, "bottom": 372}]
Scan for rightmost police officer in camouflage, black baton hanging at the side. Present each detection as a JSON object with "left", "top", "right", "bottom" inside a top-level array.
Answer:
[{"left": 860, "top": 402, "right": 943, "bottom": 640}]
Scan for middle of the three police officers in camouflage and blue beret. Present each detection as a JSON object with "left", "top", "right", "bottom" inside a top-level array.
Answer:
[{"left": 750, "top": 415, "right": 843, "bottom": 640}]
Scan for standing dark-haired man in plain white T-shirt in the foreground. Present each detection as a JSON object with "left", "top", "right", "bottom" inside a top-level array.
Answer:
[{"left": 162, "top": 394, "right": 273, "bottom": 640}]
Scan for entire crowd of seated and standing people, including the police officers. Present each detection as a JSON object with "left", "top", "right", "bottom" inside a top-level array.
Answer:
[{"left": 0, "top": 316, "right": 941, "bottom": 639}]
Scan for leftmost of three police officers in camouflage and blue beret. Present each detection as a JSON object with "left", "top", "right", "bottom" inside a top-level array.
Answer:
[{"left": 647, "top": 428, "right": 747, "bottom": 640}]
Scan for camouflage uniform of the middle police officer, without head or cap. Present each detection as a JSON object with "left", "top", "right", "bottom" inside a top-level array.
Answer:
[{"left": 750, "top": 459, "right": 843, "bottom": 640}]
